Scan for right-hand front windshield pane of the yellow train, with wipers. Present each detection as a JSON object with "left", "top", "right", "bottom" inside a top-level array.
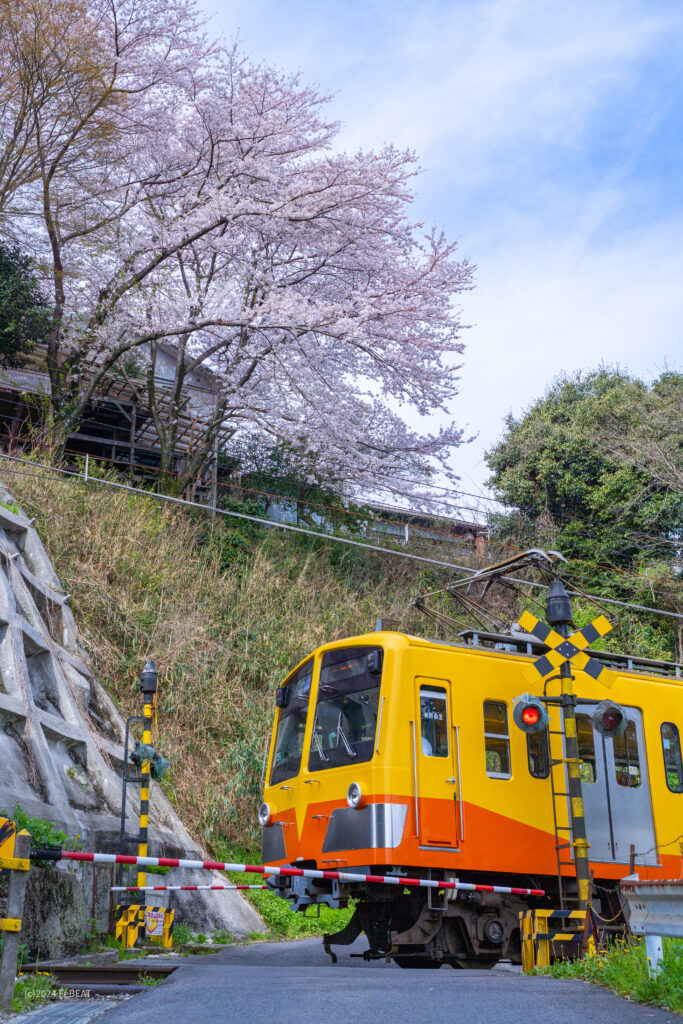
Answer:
[{"left": 308, "top": 647, "right": 382, "bottom": 771}]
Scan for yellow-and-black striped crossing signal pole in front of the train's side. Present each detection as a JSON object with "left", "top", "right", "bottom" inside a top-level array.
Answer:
[{"left": 546, "top": 580, "right": 590, "bottom": 910}]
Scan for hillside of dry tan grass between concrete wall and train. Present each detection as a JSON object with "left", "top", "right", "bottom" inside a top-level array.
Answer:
[{"left": 3, "top": 466, "right": 454, "bottom": 855}]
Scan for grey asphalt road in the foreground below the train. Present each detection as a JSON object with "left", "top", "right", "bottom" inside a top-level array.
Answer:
[{"left": 98, "top": 939, "right": 682, "bottom": 1024}]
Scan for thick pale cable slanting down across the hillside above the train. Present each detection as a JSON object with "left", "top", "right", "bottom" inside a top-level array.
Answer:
[{"left": 0, "top": 453, "right": 683, "bottom": 622}]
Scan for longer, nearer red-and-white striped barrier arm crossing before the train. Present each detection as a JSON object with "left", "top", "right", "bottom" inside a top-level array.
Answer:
[{"left": 52, "top": 850, "right": 546, "bottom": 896}]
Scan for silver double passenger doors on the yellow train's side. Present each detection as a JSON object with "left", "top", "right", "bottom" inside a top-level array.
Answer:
[{"left": 577, "top": 705, "right": 657, "bottom": 864}]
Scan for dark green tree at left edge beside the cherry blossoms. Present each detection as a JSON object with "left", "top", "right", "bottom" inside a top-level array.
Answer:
[{"left": 0, "top": 244, "right": 50, "bottom": 367}]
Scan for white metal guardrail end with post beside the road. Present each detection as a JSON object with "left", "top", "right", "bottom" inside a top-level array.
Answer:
[{"left": 622, "top": 876, "right": 683, "bottom": 977}]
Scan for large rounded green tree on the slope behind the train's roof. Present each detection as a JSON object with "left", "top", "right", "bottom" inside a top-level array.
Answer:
[{"left": 486, "top": 367, "right": 683, "bottom": 656}]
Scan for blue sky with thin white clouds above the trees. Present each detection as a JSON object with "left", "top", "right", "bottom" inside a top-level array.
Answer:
[{"left": 197, "top": 0, "right": 683, "bottom": 503}]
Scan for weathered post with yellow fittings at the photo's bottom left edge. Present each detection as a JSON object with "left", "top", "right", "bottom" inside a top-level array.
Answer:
[{"left": 0, "top": 818, "right": 31, "bottom": 1010}]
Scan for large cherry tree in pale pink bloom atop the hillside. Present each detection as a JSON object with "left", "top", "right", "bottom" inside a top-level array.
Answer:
[{"left": 0, "top": 0, "right": 472, "bottom": 503}]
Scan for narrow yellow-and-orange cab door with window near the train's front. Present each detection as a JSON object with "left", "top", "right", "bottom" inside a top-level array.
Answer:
[{"left": 415, "top": 677, "right": 458, "bottom": 850}]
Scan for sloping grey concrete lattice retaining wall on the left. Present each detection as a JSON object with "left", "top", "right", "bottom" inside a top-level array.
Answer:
[{"left": 0, "top": 485, "right": 263, "bottom": 936}]
